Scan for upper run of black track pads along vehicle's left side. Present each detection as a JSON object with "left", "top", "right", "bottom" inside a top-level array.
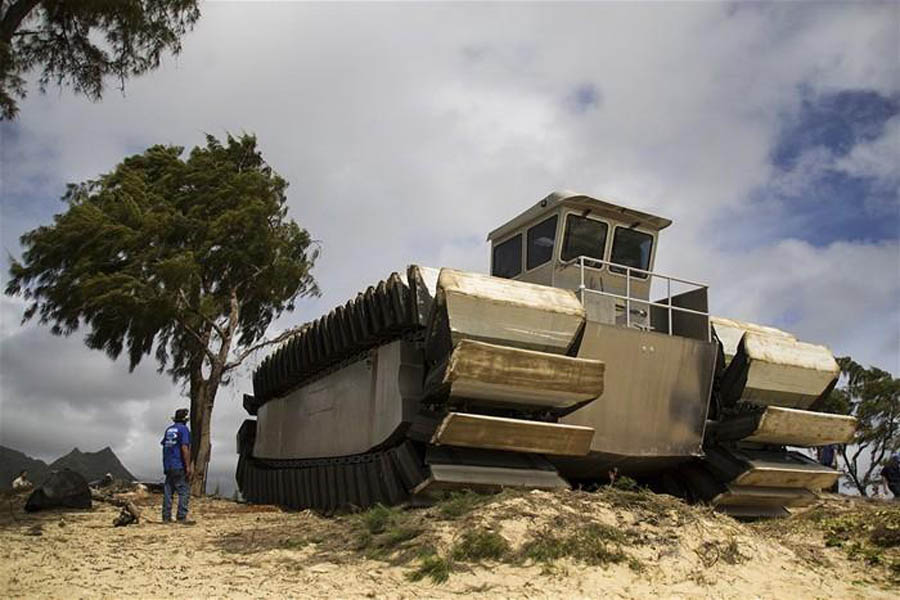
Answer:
[{"left": 248, "top": 273, "right": 422, "bottom": 414}]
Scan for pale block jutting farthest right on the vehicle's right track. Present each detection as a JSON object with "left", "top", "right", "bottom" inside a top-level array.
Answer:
[{"left": 720, "top": 406, "right": 856, "bottom": 447}]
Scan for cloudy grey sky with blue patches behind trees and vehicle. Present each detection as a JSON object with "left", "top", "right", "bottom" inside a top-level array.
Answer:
[{"left": 0, "top": 2, "right": 900, "bottom": 490}]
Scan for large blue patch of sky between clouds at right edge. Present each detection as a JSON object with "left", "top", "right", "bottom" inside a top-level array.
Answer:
[{"left": 740, "top": 90, "right": 900, "bottom": 246}]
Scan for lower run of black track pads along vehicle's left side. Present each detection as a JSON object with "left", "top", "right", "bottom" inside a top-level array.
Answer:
[{"left": 236, "top": 441, "right": 427, "bottom": 512}]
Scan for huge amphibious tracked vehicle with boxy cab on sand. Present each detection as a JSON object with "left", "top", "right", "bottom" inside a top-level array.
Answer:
[{"left": 237, "top": 192, "right": 856, "bottom": 517}]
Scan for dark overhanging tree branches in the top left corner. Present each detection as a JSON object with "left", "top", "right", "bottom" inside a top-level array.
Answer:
[{"left": 0, "top": 0, "right": 200, "bottom": 119}]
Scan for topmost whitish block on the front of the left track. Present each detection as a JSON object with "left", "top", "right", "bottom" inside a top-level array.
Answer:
[{"left": 427, "top": 269, "right": 584, "bottom": 360}]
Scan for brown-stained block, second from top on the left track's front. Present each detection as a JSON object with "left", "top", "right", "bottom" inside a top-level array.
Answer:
[{"left": 426, "top": 340, "right": 604, "bottom": 408}]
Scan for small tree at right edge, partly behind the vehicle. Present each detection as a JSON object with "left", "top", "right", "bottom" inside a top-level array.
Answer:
[{"left": 823, "top": 356, "right": 900, "bottom": 496}]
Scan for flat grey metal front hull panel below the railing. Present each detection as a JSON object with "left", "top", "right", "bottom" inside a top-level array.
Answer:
[{"left": 560, "top": 321, "right": 716, "bottom": 457}]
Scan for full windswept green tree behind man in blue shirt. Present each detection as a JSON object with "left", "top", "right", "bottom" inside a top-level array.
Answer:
[{"left": 6, "top": 135, "right": 319, "bottom": 494}]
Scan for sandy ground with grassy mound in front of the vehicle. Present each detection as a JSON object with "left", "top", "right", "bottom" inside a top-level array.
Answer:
[{"left": 0, "top": 490, "right": 900, "bottom": 599}]
